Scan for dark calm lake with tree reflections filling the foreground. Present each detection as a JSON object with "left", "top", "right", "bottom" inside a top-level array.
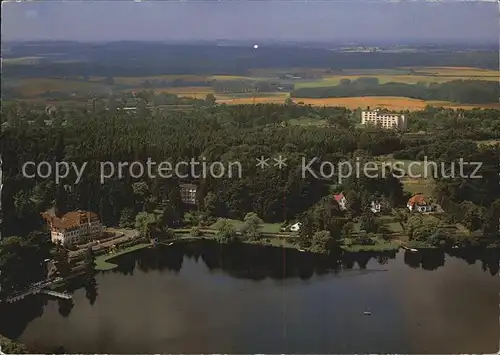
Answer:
[{"left": 0, "top": 242, "right": 500, "bottom": 354}]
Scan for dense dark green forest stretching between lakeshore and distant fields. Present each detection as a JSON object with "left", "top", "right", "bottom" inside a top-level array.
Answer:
[{"left": 2, "top": 92, "right": 500, "bottom": 242}]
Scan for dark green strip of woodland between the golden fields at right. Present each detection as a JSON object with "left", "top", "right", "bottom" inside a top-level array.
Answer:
[{"left": 291, "top": 78, "right": 500, "bottom": 104}]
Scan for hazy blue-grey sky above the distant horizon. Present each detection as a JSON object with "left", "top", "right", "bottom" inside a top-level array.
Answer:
[{"left": 2, "top": 0, "right": 500, "bottom": 41}]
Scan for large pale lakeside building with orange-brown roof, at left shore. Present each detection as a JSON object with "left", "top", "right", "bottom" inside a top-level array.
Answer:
[{"left": 42, "top": 211, "right": 104, "bottom": 246}]
